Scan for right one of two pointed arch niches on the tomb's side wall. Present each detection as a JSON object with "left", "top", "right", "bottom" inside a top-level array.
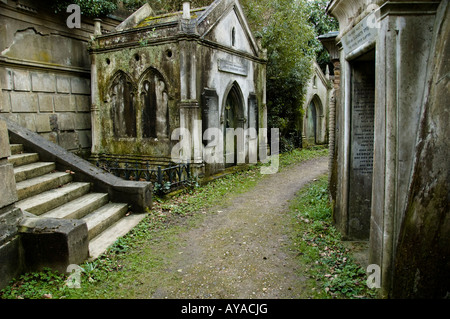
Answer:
[{"left": 140, "top": 68, "right": 169, "bottom": 138}]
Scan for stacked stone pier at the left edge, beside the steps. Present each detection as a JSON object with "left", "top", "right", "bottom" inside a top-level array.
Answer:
[{"left": 0, "top": 119, "right": 23, "bottom": 289}]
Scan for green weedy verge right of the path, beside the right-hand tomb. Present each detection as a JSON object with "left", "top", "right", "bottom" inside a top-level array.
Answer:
[{"left": 290, "top": 176, "right": 375, "bottom": 299}]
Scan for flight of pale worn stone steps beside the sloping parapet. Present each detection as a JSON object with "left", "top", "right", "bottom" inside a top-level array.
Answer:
[{"left": 8, "top": 144, "right": 145, "bottom": 259}]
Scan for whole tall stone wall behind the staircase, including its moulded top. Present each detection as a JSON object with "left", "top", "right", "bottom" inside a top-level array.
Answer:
[{"left": 0, "top": 0, "right": 120, "bottom": 156}]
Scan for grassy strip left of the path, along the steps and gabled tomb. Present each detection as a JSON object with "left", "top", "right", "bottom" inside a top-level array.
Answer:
[{"left": 0, "top": 147, "right": 328, "bottom": 299}]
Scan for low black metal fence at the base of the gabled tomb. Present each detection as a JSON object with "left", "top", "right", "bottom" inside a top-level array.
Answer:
[{"left": 96, "top": 160, "right": 192, "bottom": 191}]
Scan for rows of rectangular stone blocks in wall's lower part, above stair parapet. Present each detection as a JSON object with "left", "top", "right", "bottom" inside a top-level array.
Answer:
[{"left": 0, "top": 68, "right": 91, "bottom": 153}]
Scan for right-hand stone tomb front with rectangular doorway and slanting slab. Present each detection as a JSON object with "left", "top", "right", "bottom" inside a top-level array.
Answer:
[{"left": 328, "top": 0, "right": 450, "bottom": 298}]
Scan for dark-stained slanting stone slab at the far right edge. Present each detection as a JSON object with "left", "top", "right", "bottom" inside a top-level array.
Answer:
[{"left": 391, "top": 2, "right": 450, "bottom": 298}]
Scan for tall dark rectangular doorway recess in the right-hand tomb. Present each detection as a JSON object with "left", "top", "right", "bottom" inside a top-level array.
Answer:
[{"left": 348, "top": 50, "right": 375, "bottom": 240}]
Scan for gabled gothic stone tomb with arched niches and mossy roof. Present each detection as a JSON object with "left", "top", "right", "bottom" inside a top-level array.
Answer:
[{"left": 90, "top": 0, "right": 267, "bottom": 174}]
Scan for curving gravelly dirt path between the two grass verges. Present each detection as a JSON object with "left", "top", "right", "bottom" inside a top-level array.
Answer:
[{"left": 149, "top": 158, "right": 328, "bottom": 299}]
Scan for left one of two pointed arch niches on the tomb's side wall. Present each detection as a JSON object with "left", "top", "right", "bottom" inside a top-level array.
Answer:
[{"left": 108, "top": 71, "right": 136, "bottom": 138}]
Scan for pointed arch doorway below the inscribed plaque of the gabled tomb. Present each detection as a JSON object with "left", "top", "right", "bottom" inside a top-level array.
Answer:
[{"left": 222, "top": 82, "right": 245, "bottom": 167}]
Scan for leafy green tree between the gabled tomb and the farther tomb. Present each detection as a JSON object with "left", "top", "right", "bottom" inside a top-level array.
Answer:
[{"left": 241, "top": 0, "right": 315, "bottom": 146}]
